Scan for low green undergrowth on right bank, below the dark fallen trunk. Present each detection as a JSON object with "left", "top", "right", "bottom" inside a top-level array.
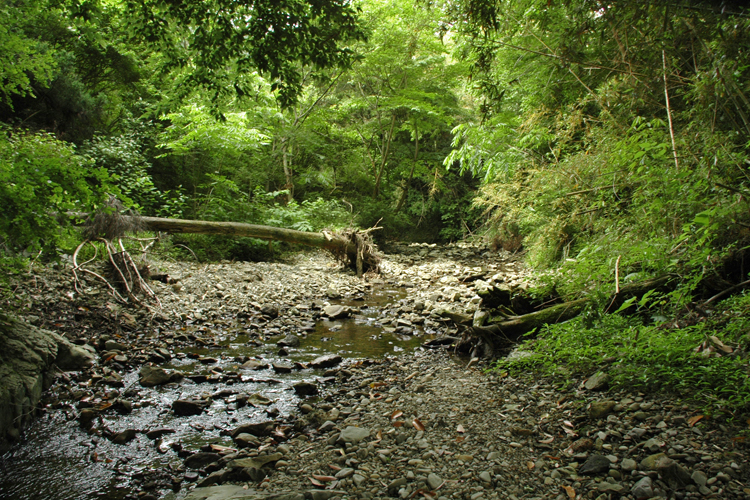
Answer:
[{"left": 494, "top": 294, "right": 750, "bottom": 417}]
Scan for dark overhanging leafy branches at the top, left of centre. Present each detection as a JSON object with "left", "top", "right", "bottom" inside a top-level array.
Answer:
[{"left": 125, "top": 0, "right": 362, "bottom": 111}]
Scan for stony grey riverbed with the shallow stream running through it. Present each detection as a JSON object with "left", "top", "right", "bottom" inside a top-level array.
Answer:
[{"left": 0, "top": 245, "right": 750, "bottom": 500}]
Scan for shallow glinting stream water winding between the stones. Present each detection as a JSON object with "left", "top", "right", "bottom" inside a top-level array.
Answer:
[{"left": 0, "top": 287, "right": 444, "bottom": 500}]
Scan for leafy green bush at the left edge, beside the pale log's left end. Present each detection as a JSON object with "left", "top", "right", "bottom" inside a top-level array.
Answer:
[{"left": 0, "top": 129, "right": 117, "bottom": 253}]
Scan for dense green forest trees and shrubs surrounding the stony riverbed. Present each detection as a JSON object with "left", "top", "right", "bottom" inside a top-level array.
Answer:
[{"left": 0, "top": 0, "right": 750, "bottom": 411}]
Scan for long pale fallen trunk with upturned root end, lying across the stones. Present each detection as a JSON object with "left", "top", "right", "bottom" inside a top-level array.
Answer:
[{"left": 127, "top": 216, "right": 379, "bottom": 276}]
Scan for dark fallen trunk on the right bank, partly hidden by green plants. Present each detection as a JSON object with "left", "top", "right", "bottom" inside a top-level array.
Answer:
[{"left": 468, "top": 274, "right": 676, "bottom": 357}]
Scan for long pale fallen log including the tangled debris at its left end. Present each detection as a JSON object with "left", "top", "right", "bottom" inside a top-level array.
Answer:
[{"left": 73, "top": 212, "right": 380, "bottom": 276}]
